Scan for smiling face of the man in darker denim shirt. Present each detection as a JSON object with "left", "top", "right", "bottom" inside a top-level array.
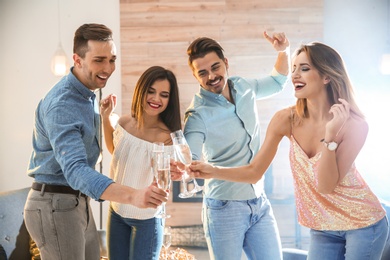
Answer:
[{"left": 73, "top": 40, "right": 116, "bottom": 90}]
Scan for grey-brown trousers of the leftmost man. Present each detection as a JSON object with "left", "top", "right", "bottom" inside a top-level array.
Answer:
[{"left": 24, "top": 190, "right": 100, "bottom": 260}]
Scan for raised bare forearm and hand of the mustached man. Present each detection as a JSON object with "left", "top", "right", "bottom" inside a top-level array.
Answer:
[{"left": 263, "top": 31, "right": 290, "bottom": 75}]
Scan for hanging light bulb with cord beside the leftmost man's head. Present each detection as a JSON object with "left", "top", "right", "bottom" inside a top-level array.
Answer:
[{"left": 51, "top": 0, "right": 69, "bottom": 76}]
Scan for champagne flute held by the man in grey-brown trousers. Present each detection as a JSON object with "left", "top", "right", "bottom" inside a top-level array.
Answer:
[{"left": 154, "top": 152, "right": 171, "bottom": 218}]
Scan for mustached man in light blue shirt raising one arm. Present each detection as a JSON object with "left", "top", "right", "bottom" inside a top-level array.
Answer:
[{"left": 184, "top": 32, "right": 289, "bottom": 260}]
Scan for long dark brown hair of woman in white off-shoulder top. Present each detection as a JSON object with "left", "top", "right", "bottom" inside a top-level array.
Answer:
[{"left": 131, "top": 66, "right": 181, "bottom": 132}]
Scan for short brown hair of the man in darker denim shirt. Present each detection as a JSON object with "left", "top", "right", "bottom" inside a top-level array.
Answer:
[{"left": 73, "top": 23, "right": 112, "bottom": 58}]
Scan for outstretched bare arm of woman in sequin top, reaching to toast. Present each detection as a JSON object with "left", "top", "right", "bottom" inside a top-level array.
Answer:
[{"left": 189, "top": 109, "right": 290, "bottom": 183}]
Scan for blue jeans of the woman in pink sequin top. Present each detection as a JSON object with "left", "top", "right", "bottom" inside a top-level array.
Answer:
[{"left": 307, "top": 217, "right": 389, "bottom": 260}]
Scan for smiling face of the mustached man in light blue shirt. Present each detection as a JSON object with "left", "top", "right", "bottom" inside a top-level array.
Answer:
[{"left": 192, "top": 52, "right": 228, "bottom": 94}]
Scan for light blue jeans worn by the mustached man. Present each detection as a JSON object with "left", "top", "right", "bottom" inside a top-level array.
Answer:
[{"left": 202, "top": 195, "right": 282, "bottom": 260}]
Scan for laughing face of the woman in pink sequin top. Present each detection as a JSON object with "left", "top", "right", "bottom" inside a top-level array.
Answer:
[{"left": 291, "top": 52, "right": 329, "bottom": 98}]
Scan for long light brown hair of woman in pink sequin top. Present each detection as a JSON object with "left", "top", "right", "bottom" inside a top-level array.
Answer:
[{"left": 293, "top": 42, "right": 364, "bottom": 120}]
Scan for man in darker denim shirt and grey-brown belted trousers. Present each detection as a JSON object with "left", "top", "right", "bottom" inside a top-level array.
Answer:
[{"left": 24, "top": 24, "right": 168, "bottom": 260}]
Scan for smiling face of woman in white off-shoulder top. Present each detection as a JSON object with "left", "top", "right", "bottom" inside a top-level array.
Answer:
[{"left": 144, "top": 79, "right": 171, "bottom": 115}]
